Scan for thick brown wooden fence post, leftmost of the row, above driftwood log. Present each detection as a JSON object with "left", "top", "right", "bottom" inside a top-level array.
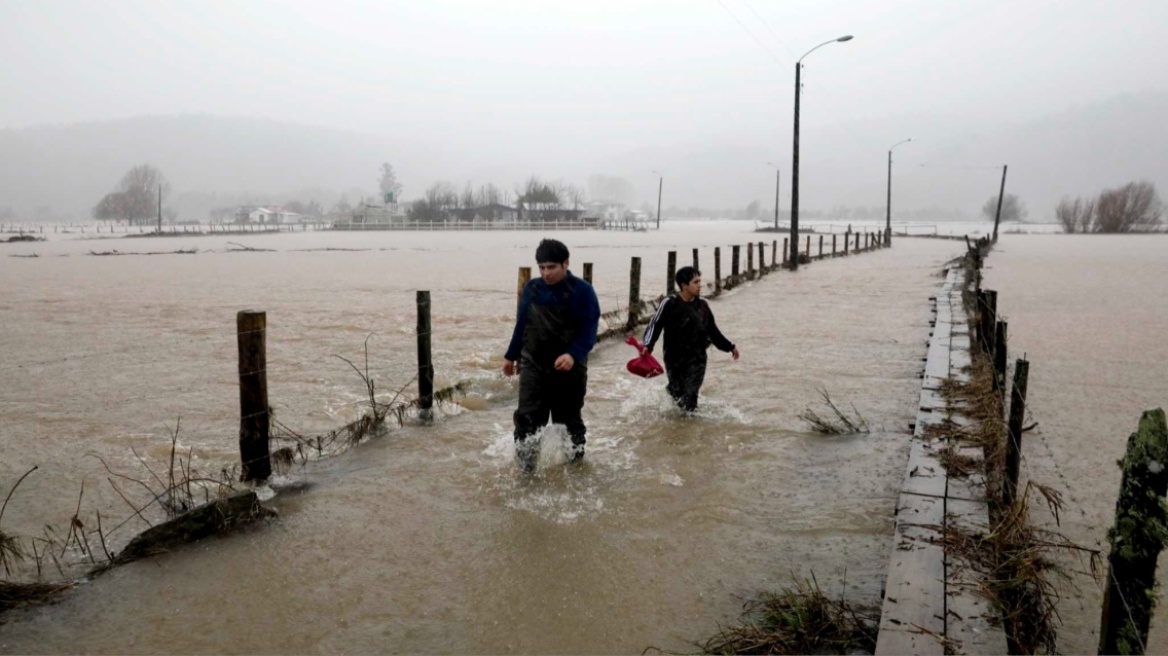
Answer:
[{"left": 235, "top": 309, "right": 272, "bottom": 481}]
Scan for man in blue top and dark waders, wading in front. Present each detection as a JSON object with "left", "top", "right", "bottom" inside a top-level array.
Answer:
[{"left": 503, "top": 239, "right": 600, "bottom": 474}]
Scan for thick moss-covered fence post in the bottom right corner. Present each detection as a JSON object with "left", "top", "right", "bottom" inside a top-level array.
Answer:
[{"left": 1099, "top": 407, "right": 1168, "bottom": 654}]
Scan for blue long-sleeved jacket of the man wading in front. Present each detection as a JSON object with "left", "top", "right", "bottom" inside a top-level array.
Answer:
[{"left": 503, "top": 271, "right": 600, "bottom": 367}]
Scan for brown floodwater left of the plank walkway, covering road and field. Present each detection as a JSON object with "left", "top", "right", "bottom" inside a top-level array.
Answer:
[{"left": 0, "top": 224, "right": 962, "bottom": 654}]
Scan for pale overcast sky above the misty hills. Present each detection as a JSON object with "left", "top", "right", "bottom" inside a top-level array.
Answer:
[{"left": 0, "top": 0, "right": 1168, "bottom": 210}]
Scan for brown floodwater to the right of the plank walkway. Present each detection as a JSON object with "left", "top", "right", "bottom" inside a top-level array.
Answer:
[{"left": 983, "top": 235, "right": 1168, "bottom": 654}]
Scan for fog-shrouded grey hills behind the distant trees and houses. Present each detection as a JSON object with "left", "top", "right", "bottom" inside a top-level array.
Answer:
[{"left": 0, "top": 92, "right": 1168, "bottom": 221}]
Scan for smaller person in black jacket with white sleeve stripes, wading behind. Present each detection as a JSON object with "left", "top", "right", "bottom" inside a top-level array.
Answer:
[{"left": 641, "top": 266, "right": 738, "bottom": 412}]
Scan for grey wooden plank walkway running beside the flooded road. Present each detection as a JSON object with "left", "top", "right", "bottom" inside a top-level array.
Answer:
[{"left": 876, "top": 268, "right": 1007, "bottom": 656}]
